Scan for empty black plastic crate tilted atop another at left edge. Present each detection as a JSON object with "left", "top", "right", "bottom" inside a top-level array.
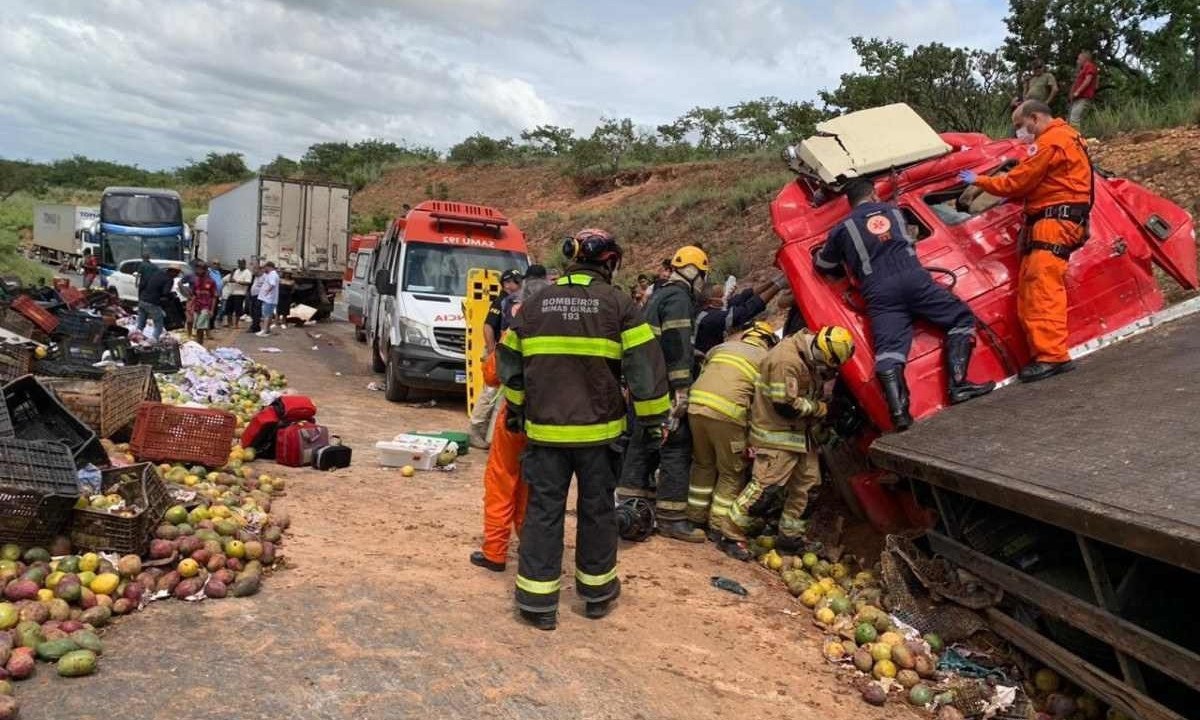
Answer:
[{"left": 4, "top": 376, "right": 107, "bottom": 467}]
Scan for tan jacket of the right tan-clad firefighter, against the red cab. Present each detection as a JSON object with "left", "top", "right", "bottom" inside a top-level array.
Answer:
[{"left": 750, "top": 330, "right": 821, "bottom": 452}]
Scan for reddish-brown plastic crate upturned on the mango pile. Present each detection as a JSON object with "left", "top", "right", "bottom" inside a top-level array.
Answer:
[{"left": 130, "top": 402, "right": 238, "bottom": 468}]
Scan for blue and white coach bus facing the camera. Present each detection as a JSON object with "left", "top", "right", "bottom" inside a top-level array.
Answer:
[{"left": 86, "top": 187, "right": 192, "bottom": 268}]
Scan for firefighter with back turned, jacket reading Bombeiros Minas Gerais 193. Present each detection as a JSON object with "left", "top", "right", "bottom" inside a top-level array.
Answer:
[{"left": 497, "top": 229, "right": 671, "bottom": 630}]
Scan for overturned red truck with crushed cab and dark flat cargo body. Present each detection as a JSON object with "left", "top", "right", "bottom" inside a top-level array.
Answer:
[{"left": 770, "top": 104, "right": 1200, "bottom": 720}]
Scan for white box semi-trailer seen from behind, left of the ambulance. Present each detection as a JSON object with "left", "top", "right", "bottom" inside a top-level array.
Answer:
[{"left": 205, "top": 176, "right": 350, "bottom": 319}]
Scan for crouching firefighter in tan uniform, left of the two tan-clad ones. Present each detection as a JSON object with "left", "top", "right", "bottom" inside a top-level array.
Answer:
[{"left": 688, "top": 320, "right": 776, "bottom": 560}]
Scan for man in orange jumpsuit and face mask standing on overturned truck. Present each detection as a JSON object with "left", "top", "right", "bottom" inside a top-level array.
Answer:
[{"left": 959, "top": 101, "right": 1094, "bottom": 383}]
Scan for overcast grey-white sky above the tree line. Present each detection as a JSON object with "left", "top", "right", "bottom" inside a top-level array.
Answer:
[{"left": 0, "top": 0, "right": 1007, "bottom": 168}]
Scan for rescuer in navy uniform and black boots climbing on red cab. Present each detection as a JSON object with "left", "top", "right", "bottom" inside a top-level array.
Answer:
[{"left": 812, "top": 178, "right": 996, "bottom": 431}]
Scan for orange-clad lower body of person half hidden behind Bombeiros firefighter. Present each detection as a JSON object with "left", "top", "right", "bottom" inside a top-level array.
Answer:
[{"left": 470, "top": 340, "right": 529, "bottom": 572}]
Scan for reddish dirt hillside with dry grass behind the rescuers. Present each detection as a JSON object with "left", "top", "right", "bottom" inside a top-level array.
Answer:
[{"left": 354, "top": 127, "right": 1200, "bottom": 282}]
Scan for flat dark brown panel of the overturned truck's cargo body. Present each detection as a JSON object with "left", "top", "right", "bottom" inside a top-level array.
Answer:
[{"left": 871, "top": 314, "right": 1200, "bottom": 572}]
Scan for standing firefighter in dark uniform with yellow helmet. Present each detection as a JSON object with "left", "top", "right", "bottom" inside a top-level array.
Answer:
[{"left": 617, "top": 245, "right": 708, "bottom": 542}]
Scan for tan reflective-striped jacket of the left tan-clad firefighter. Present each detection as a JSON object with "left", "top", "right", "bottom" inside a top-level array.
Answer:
[{"left": 688, "top": 340, "right": 767, "bottom": 427}]
